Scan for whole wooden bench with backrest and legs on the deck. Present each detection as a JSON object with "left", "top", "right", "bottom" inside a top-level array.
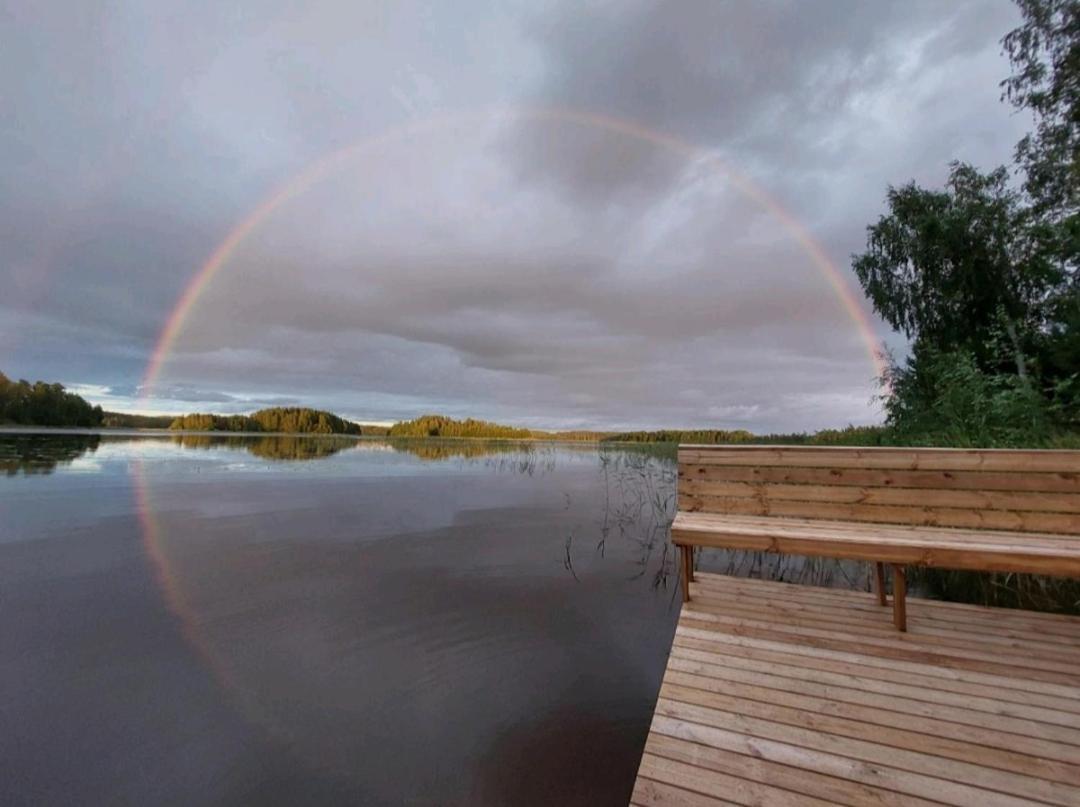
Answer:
[{"left": 672, "top": 445, "right": 1080, "bottom": 631}]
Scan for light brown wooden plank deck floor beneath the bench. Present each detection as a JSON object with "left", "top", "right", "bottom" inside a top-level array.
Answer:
[{"left": 631, "top": 573, "right": 1080, "bottom": 807}]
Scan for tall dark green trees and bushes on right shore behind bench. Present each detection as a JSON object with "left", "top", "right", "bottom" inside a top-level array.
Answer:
[{"left": 852, "top": 0, "right": 1080, "bottom": 446}]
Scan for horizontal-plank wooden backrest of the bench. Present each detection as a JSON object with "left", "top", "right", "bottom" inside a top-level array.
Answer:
[{"left": 678, "top": 445, "right": 1080, "bottom": 535}]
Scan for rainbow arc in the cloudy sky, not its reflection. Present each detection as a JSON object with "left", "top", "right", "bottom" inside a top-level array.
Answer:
[{"left": 139, "top": 107, "right": 885, "bottom": 401}]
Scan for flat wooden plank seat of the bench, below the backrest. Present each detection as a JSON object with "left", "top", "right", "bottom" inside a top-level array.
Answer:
[{"left": 672, "top": 511, "right": 1080, "bottom": 577}]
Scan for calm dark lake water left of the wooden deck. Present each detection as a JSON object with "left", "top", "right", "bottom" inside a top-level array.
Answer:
[{"left": 0, "top": 435, "right": 678, "bottom": 805}]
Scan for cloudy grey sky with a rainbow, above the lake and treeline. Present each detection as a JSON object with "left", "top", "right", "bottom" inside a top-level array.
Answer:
[{"left": 0, "top": 0, "right": 1029, "bottom": 432}]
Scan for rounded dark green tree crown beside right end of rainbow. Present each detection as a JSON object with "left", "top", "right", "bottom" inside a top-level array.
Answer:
[{"left": 852, "top": 163, "right": 1069, "bottom": 377}]
